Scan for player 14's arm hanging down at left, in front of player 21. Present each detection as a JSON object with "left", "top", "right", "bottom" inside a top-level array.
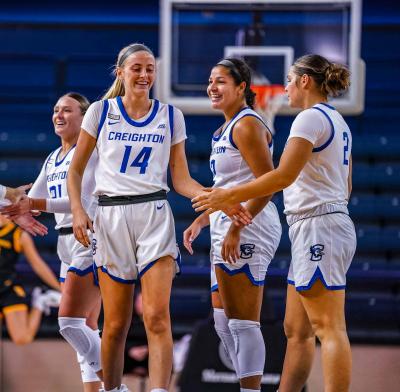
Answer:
[{"left": 67, "top": 129, "right": 96, "bottom": 247}]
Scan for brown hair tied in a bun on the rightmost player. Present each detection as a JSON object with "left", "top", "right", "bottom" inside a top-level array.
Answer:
[{"left": 292, "top": 54, "right": 350, "bottom": 97}]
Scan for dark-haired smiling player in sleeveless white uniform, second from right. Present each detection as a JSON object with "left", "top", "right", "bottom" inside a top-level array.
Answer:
[{"left": 184, "top": 58, "right": 282, "bottom": 391}]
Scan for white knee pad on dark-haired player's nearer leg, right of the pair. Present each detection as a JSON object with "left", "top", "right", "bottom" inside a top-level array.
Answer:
[{"left": 228, "top": 319, "right": 265, "bottom": 379}]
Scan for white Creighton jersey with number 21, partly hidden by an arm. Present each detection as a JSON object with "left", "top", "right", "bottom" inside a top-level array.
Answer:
[{"left": 29, "top": 146, "right": 97, "bottom": 229}]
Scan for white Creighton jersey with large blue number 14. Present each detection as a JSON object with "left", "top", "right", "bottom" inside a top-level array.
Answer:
[{"left": 82, "top": 97, "right": 186, "bottom": 196}]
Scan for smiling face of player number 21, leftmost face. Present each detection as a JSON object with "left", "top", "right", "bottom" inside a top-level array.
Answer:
[{"left": 53, "top": 96, "right": 83, "bottom": 139}]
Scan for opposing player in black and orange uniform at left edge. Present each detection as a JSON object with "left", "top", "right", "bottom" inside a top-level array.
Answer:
[{"left": 0, "top": 215, "right": 61, "bottom": 345}]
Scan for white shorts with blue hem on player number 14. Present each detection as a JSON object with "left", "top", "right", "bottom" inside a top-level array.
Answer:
[{"left": 93, "top": 200, "right": 180, "bottom": 283}]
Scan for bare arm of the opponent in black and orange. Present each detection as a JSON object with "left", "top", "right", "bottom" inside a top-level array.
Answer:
[{"left": 20, "top": 232, "right": 60, "bottom": 291}]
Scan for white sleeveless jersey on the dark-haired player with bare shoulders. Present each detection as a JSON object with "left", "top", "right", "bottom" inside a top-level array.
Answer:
[{"left": 210, "top": 107, "right": 273, "bottom": 188}]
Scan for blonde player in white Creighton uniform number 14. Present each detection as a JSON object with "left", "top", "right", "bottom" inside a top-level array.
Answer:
[{"left": 68, "top": 44, "right": 227, "bottom": 392}]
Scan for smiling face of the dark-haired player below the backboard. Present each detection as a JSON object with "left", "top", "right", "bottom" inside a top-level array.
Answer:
[{"left": 207, "top": 65, "right": 246, "bottom": 111}]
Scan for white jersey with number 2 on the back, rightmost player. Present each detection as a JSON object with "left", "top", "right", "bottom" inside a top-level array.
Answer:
[{"left": 283, "top": 103, "right": 352, "bottom": 214}]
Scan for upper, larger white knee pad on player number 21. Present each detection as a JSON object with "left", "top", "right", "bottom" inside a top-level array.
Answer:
[{"left": 58, "top": 317, "right": 101, "bottom": 372}]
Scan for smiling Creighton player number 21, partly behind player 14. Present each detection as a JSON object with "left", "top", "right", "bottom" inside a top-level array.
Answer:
[{"left": 3, "top": 93, "right": 101, "bottom": 392}]
